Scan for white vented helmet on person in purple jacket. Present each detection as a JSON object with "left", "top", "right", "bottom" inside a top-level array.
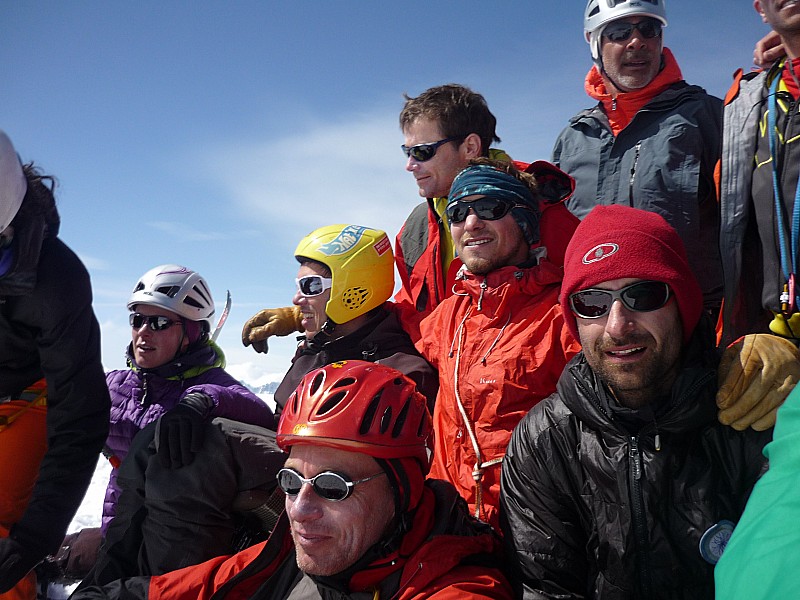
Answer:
[{"left": 128, "top": 265, "right": 214, "bottom": 331}]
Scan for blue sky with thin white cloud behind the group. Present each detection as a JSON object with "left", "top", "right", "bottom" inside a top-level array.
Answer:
[{"left": 0, "top": 0, "right": 767, "bottom": 383}]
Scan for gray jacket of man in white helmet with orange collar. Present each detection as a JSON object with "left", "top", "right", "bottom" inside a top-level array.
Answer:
[{"left": 553, "top": 81, "right": 722, "bottom": 308}]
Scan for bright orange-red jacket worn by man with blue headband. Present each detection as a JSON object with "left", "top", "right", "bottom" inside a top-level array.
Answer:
[{"left": 417, "top": 260, "right": 580, "bottom": 529}]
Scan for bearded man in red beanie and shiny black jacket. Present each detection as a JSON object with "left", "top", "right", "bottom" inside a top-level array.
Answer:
[{"left": 501, "top": 206, "right": 771, "bottom": 599}]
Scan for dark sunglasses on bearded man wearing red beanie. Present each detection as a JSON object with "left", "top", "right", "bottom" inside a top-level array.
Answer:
[{"left": 569, "top": 281, "right": 670, "bottom": 319}]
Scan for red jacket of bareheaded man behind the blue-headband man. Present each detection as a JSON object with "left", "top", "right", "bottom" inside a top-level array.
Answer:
[{"left": 394, "top": 161, "right": 580, "bottom": 340}]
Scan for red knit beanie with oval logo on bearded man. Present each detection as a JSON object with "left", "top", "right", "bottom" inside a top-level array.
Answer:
[{"left": 561, "top": 205, "right": 703, "bottom": 342}]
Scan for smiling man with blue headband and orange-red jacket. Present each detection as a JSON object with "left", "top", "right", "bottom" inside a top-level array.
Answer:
[{"left": 417, "top": 158, "right": 580, "bottom": 527}]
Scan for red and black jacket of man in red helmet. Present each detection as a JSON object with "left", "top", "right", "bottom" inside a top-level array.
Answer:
[{"left": 72, "top": 481, "right": 513, "bottom": 600}]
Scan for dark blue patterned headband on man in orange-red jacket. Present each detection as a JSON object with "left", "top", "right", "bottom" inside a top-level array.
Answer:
[{"left": 447, "top": 165, "right": 539, "bottom": 244}]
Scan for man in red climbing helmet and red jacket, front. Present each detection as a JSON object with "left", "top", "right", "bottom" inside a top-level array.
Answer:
[{"left": 72, "top": 361, "right": 512, "bottom": 600}]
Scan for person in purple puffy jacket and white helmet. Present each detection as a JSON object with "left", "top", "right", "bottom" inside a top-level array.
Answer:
[{"left": 64, "top": 265, "right": 276, "bottom": 575}]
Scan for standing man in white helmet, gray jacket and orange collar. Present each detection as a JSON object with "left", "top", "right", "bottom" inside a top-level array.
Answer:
[{"left": 553, "top": 0, "right": 722, "bottom": 317}]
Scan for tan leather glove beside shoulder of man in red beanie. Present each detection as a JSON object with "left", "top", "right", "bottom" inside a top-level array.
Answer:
[{"left": 717, "top": 333, "right": 800, "bottom": 431}]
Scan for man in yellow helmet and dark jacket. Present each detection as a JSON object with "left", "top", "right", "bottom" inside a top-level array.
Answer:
[{"left": 275, "top": 225, "right": 438, "bottom": 414}]
